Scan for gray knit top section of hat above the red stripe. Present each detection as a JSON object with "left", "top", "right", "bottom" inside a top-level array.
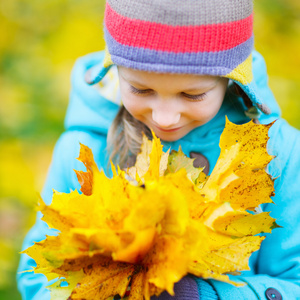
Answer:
[{"left": 107, "top": 0, "right": 253, "bottom": 26}]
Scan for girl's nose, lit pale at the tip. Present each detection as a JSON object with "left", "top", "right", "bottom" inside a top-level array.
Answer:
[{"left": 152, "top": 106, "right": 180, "bottom": 128}]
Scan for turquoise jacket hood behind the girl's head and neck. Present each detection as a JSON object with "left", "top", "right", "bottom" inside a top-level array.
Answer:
[{"left": 65, "top": 51, "right": 280, "bottom": 138}]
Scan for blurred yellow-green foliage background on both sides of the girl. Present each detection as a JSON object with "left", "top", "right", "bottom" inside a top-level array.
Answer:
[{"left": 0, "top": 0, "right": 300, "bottom": 300}]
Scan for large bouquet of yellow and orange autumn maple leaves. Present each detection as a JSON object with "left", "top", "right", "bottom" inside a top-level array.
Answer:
[{"left": 24, "top": 120, "right": 277, "bottom": 300}]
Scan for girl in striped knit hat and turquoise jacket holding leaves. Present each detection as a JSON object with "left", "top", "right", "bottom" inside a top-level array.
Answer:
[{"left": 18, "top": 0, "right": 300, "bottom": 300}]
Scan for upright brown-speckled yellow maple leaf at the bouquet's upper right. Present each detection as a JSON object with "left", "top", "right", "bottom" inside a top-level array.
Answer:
[{"left": 202, "top": 120, "right": 274, "bottom": 210}]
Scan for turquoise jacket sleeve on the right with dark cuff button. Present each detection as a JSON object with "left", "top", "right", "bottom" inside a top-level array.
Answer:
[{"left": 210, "top": 120, "right": 300, "bottom": 300}]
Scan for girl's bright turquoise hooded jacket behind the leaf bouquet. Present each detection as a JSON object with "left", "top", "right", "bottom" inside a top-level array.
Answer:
[{"left": 18, "top": 52, "right": 300, "bottom": 300}]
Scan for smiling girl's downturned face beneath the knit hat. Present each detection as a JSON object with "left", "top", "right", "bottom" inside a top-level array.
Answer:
[{"left": 119, "top": 67, "right": 228, "bottom": 141}]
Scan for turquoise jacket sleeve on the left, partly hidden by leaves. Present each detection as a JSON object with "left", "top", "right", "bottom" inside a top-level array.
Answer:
[{"left": 17, "top": 131, "right": 106, "bottom": 300}]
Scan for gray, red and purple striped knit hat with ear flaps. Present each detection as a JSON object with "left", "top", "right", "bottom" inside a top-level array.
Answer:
[{"left": 90, "top": 0, "right": 270, "bottom": 115}]
